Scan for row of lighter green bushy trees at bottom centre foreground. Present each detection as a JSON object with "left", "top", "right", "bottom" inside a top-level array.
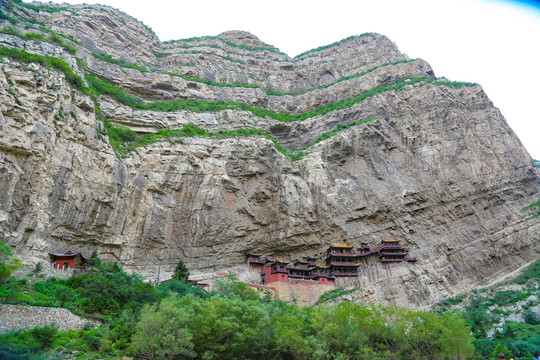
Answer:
[{"left": 133, "top": 294, "right": 473, "bottom": 359}]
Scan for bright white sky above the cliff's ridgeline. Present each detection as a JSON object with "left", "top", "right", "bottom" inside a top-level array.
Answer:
[{"left": 37, "top": 0, "right": 540, "bottom": 159}]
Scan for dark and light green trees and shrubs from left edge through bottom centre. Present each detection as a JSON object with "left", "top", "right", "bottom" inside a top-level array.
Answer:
[{"left": 0, "top": 239, "right": 473, "bottom": 360}]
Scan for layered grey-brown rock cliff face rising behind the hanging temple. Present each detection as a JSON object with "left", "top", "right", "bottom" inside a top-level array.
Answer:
[{"left": 0, "top": 0, "right": 540, "bottom": 305}]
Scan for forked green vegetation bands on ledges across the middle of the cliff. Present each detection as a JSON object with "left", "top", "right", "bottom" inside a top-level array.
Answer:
[{"left": 0, "top": 47, "right": 474, "bottom": 160}]
